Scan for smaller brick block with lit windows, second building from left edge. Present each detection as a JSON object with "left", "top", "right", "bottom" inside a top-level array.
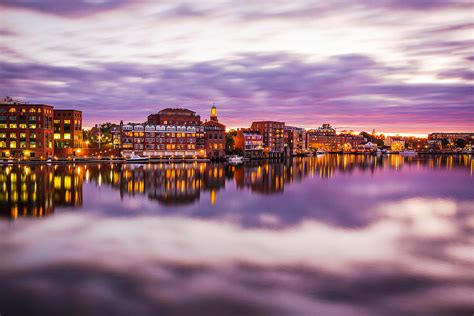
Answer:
[{"left": 53, "top": 110, "right": 82, "bottom": 148}]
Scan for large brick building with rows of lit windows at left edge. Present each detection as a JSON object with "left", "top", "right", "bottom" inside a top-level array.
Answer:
[{"left": 0, "top": 97, "right": 54, "bottom": 158}]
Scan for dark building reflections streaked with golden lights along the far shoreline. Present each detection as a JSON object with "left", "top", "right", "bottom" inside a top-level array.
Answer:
[{"left": 0, "top": 155, "right": 474, "bottom": 219}]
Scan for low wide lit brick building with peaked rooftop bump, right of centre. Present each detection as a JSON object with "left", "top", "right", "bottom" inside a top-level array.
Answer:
[{"left": 306, "top": 124, "right": 367, "bottom": 152}]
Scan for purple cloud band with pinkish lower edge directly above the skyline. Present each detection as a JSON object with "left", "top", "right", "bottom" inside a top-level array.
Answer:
[{"left": 0, "top": 54, "right": 474, "bottom": 131}]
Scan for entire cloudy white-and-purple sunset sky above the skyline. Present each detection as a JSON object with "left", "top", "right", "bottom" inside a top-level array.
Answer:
[{"left": 0, "top": 0, "right": 474, "bottom": 134}]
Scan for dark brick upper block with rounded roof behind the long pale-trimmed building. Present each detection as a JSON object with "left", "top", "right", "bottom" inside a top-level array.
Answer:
[{"left": 147, "top": 108, "right": 201, "bottom": 126}]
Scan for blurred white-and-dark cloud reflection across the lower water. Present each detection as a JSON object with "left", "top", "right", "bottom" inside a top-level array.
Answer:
[{"left": 0, "top": 198, "right": 474, "bottom": 315}]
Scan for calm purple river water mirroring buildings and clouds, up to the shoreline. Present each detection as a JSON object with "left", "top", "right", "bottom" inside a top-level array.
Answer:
[{"left": 0, "top": 155, "right": 474, "bottom": 316}]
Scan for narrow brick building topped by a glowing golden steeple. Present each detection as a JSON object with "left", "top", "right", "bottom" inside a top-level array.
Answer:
[{"left": 202, "top": 106, "right": 225, "bottom": 159}]
